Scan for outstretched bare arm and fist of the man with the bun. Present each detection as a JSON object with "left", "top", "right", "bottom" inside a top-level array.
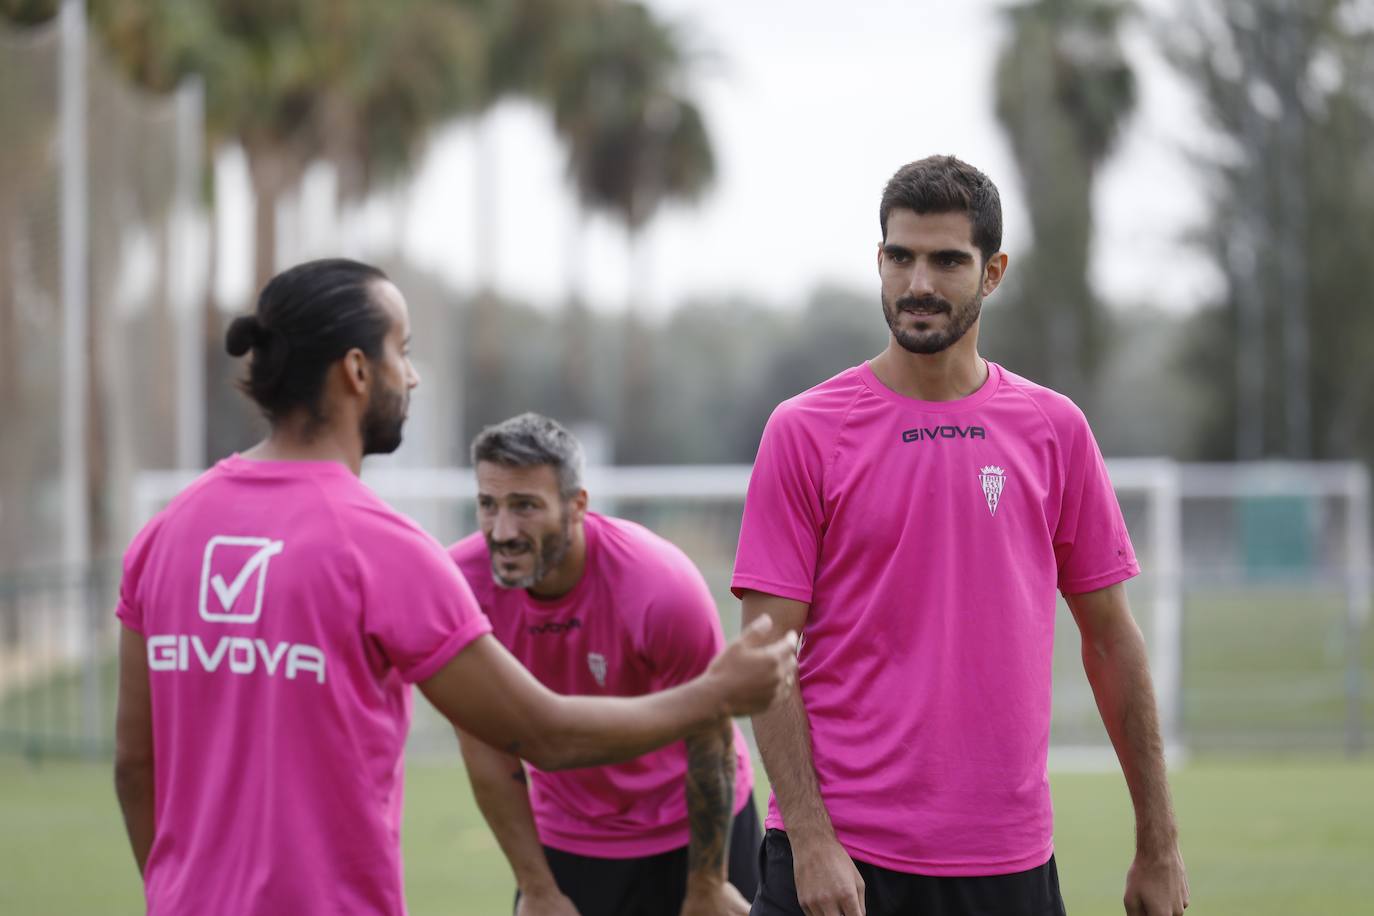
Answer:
[{"left": 419, "top": 621, "right": 797, "bottom": 770}]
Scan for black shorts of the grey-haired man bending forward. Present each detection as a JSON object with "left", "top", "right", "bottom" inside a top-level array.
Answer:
[{"left": 515, "top": 795, "right": 763, "bottom": 916}]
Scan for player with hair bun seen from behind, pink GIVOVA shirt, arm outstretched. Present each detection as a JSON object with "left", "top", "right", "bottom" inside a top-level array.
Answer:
[{"left": 115, "top": 260, "right": 793, "bottom": 916}]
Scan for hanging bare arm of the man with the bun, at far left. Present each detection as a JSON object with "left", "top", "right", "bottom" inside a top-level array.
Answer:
[{"left": 114, "top": 626, "right": 154, "bottom": 875}]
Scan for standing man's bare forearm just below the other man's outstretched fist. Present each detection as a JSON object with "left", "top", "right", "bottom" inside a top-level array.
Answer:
[{"left": 753, "top": 689, "right": 835, "bottom": 845}]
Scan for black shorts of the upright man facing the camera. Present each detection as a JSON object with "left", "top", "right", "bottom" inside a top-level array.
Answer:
[{"left": 749, "top": 829, "right": 1063, "bottom": 916}]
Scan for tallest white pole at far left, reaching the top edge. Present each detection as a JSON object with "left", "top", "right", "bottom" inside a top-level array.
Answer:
[{"left": 59, "top": 0, "right": 91, "bottom": 575}]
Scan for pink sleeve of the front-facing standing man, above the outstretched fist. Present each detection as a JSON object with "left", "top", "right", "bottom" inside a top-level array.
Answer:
[{"left": 730, "top": 402, "right": 824, "bottom": 603}]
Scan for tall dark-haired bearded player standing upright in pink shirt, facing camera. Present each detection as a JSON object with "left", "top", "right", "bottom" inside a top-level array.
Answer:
[{"left": 732, "top": 157, "right": 1189, "bottom": 916}]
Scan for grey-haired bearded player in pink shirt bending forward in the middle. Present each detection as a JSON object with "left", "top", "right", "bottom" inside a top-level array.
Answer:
[{"left": 449, "top": 413, "right": 761, "bottom": 916}]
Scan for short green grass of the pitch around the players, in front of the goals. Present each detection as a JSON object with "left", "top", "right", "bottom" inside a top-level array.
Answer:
[{"left": 0, "top": 755, "right": 1374, "bottom": 916}]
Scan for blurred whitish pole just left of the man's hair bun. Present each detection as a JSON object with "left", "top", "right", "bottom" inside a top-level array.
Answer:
[{"left": 169, "top": 78, "right": 206, "bottom": 471}]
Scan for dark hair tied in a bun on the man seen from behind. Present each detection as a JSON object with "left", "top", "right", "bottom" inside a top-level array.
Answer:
[{"left": 224, "top": 258, "right": 392, "bottom": 423}]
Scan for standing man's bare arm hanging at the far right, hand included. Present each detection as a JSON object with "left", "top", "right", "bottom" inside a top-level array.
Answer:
[{"left": 1065, "top": 584, "right": 1189, "bottom": 916}]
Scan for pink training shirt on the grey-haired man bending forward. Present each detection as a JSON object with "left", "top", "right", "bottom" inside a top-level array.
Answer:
[{"left": 449, "top": 512, "right": 753, "bottom": 858}]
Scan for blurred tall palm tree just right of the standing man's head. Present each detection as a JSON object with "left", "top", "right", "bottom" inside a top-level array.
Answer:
[{"left": 988, "top": 0, "right": 1136, "bottom": 402}]
